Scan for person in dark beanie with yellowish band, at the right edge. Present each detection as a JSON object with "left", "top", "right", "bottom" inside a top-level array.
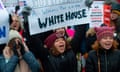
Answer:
[{"left": 110, "top": 3, "right": 120, "bottom": 48}]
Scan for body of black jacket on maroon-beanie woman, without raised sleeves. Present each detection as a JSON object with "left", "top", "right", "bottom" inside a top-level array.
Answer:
[{"left": 41, "top": 51, "right": 77, "bottom": 72}]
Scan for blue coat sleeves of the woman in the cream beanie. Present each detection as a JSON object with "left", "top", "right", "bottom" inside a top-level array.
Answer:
[{"left": 0, "top": 52, "right": 40, "bottom": 72}]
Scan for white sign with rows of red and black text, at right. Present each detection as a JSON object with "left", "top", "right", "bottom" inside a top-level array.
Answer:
[{"left": 90, "top": 1, "right": 104, "bottom": 27}]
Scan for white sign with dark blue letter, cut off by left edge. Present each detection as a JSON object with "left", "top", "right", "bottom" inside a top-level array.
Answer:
[{"left": 0, "top": 0, "right": 9, "bottom": 44}]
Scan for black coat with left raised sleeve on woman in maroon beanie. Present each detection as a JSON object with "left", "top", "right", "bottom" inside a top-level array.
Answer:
[{"left": 36, "top": 39, "right": 77, "bottom": 72}]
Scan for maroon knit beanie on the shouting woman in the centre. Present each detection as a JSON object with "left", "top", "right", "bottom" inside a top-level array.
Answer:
[{"left": 44, "top": 33, "right": 64, "bottom": 48}]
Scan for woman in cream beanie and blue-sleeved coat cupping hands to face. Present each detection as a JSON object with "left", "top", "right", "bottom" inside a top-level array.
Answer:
[{"left": 0, "top": 30, "right": 40, "bottom": 72}]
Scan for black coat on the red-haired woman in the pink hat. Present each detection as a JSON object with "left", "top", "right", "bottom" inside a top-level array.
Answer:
[{"left": 86, "top": 49, "right": 120, "bottom": 72}]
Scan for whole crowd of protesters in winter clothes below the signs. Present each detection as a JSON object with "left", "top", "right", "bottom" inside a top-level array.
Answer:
[{"left": 0, "top": 0, "right": 120, "bottom": 72}]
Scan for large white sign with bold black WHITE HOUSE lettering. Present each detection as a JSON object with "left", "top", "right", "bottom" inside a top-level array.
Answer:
[{"left": 29, "top": 0, "right": 90, "bottom": 35}]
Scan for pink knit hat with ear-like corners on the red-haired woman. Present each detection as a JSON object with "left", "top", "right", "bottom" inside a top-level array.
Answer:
[{"left": 94, "top": 26, "right": 114, "bottom": 41}]
